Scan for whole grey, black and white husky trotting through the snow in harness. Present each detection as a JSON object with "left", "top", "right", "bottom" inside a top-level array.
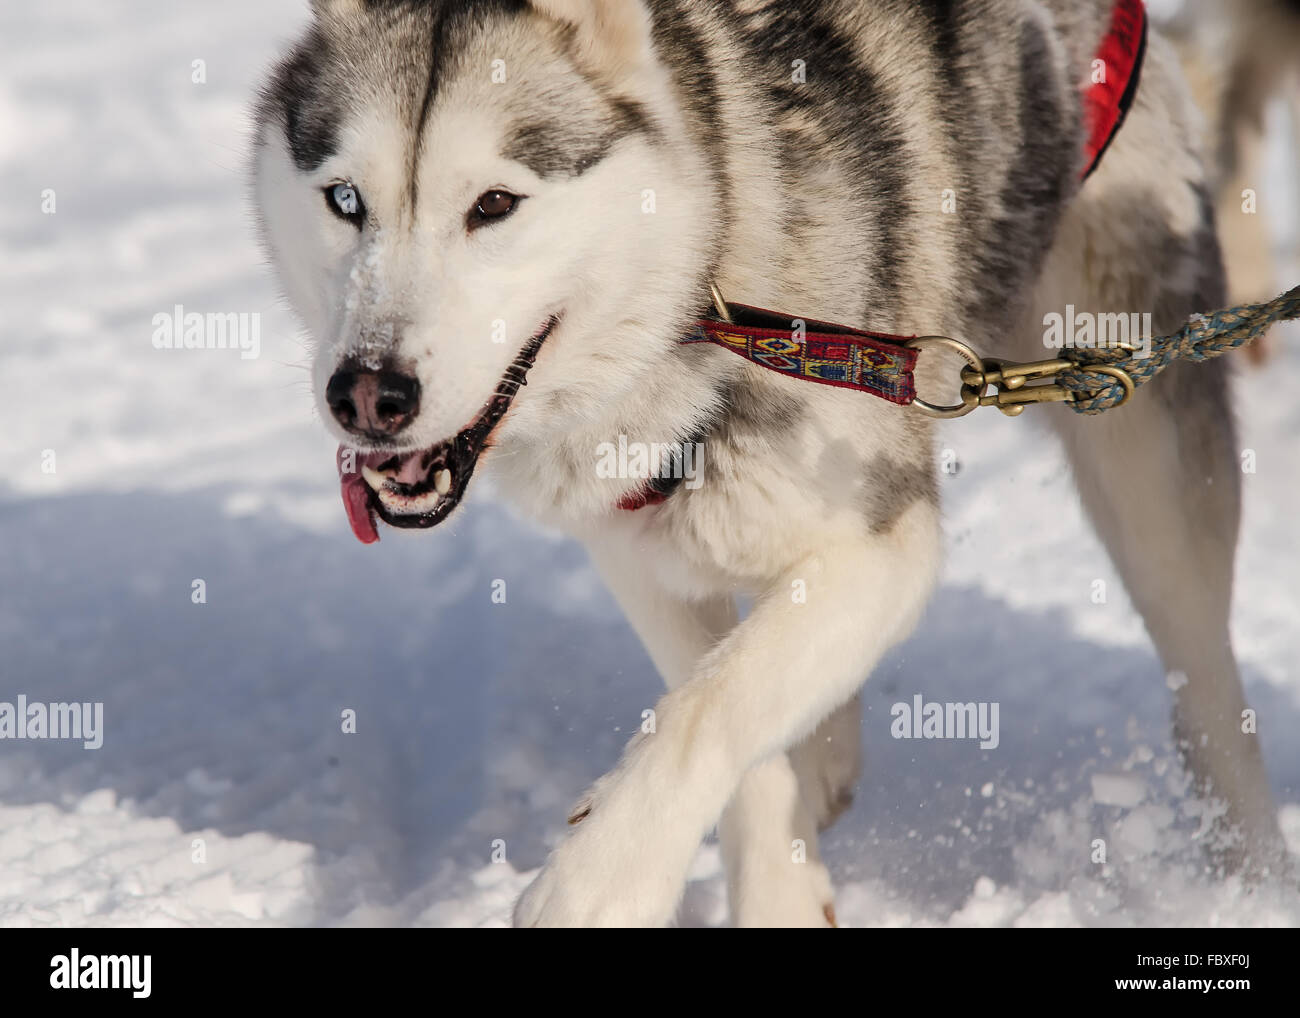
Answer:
[{"left": 255, "top": 0, "right": 1283, "bottom": 926}]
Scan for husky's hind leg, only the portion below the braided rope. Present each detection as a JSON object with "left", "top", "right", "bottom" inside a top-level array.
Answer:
[{"left": 1054, "top": 363, "right": 1282, "bottom": 867}]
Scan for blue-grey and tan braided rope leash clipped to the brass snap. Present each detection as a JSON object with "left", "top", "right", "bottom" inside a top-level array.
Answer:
[{"left": 1056, "top": 286, "right": 1300, "bottom": 413}]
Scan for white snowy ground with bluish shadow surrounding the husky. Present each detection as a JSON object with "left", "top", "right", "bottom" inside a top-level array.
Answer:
[{"left": 0, "top": 0, "right": 1300, "bottom": 926}]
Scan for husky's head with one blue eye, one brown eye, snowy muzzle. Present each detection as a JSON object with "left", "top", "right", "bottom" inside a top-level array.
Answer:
[{"left": 254, "top": 0, "right": 707, "bottom": 542}]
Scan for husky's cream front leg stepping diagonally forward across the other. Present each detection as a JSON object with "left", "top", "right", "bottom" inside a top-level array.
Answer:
[{"left": 515, "top": 514, "right": 939, "bottom": 926}]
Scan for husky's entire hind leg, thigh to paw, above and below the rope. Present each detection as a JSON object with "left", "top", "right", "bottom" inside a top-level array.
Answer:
[{"left": 1018, "top": 35, "right": 1284, "bottom": 870}]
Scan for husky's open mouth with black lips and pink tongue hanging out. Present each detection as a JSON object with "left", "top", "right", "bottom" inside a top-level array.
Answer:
[{"left": 338, "top": 315, "right": 559, "bottom": 545}]
